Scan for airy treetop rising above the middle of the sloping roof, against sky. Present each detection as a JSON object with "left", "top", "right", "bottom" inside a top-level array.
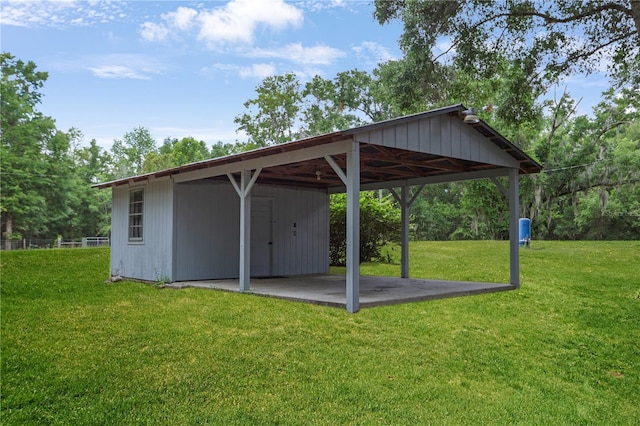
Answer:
[{"left": 234, "top": 73, "right": 302, "bottom": 147}]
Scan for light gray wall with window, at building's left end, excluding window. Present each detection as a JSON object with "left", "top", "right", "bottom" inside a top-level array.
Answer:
[{"left": 111, "top": 180, "right": 173, "bottom": 281}]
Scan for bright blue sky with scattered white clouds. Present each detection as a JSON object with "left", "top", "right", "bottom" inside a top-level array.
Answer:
[{"left": 0, "top": 0, "right": 608, "bottom": 149}]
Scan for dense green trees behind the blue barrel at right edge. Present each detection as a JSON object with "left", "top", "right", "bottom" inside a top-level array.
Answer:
[{"left": 521, "top": 85, "right": 640, "bottom": 239}]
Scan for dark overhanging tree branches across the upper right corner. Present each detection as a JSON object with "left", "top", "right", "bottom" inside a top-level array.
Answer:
[{"left": 374, "top": 0, "right": 640, "bottom": 107}]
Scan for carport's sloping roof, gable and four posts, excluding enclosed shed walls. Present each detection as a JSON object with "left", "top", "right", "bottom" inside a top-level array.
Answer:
[{"left": 97, "top": 105, "right": 541, "bottom": 312}]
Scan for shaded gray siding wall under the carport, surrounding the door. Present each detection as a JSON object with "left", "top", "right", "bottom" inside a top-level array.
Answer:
[{"left": 175, "top": 181, "right": 329, "bottom": 281}]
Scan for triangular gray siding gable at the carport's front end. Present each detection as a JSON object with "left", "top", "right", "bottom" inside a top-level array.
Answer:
[{"left": 355, "top": 116, "right": 519, "bottom": 167}]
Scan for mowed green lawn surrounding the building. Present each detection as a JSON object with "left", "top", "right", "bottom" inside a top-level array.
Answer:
[{"left": 0, "top": 241, "right": 640, "bottom": 425}]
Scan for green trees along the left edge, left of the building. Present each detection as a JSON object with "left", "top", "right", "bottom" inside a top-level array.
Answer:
[{"left": 0, "top": 53, "right": 111, "bottom": 243}]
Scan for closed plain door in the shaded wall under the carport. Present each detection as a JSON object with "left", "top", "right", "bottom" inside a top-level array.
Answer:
[{"left": 251, "top": 197, "right": 273, "bottom": 277}]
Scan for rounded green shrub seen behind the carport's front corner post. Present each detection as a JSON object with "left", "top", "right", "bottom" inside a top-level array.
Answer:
[{"left": 329, "top": 192, "right": 400, "bottom": 265}]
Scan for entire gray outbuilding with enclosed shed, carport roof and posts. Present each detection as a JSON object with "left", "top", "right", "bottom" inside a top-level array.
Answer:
[{"left": 95, "top": 105, "right": 541, "bottom": 312}]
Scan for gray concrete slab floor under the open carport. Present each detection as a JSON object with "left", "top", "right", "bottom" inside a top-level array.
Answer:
[{"left": 167, "top": 274, "right": 516, "bottom": 308}]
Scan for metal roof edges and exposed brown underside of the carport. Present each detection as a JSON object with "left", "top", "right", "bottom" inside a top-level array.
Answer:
[{"left": 93, "top": 104, "right": 542, "bottom": 189}]
